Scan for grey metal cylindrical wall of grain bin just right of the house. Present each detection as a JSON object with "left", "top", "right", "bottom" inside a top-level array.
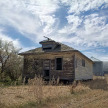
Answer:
[{"left": 93, "top": 61, "right": 104, "bottom": 76}]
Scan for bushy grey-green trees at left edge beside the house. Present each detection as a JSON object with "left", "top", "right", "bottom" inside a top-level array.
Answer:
[{"left": 0, "top": 40, "right": 23, "bottom": 85}]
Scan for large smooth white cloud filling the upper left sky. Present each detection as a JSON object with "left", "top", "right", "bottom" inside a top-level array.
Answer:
[{"left": 0, "top": 0, "right": 59, "bottom": 42}]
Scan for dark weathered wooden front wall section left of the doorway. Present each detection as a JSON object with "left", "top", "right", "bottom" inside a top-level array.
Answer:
[{"left": 22, "top": 56, "right": 42, "bottom": 78}]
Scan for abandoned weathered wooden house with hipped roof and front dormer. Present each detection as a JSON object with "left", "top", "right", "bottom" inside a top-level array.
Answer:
[{"left": 20, "top": 38, "right": 93, "bottom": 81}]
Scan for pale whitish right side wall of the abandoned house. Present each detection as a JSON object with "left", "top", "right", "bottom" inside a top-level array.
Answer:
[{"left": 75, "top": 53, "right": 93, "bottom": 80}]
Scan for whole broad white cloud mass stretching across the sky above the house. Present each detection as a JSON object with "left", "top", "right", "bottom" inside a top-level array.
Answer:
[{"left": 0, "top": 0, "right": 107, "bottom": 46}]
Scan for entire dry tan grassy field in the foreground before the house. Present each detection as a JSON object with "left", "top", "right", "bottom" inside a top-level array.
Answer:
[{"left": 0, "top": 77, "right": 108, "bottom": 108}]
